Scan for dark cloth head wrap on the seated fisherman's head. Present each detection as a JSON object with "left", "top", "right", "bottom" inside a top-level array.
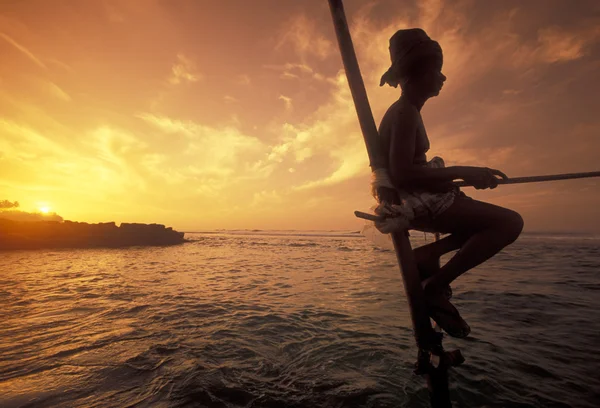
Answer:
[{"left": 379, "top": 28, "right": 443, "bottom": 88}]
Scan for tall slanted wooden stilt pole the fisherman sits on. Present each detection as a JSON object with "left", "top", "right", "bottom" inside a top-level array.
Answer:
[{"left": 328, "top": 0, "right": 464, "bottom": 408}]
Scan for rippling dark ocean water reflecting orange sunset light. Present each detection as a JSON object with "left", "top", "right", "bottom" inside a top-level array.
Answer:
[{"left": 0, "top": 231, "right": 600, "bottom": 408}]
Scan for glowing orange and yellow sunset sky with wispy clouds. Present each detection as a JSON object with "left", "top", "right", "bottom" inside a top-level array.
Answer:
[{"left": 0, "top": 0, "right": 600, "bottom": 231}]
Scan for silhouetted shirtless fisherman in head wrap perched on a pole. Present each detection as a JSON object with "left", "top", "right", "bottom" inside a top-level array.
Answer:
[{"left": 379, "top": 28, "right": 523, "bottom": 338}]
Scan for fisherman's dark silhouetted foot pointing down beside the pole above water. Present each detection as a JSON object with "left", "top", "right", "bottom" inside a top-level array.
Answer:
[{"left": 423, "top": 285, "right": 471, "bottom": 339}]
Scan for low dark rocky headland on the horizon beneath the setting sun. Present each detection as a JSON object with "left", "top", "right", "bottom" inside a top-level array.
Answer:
[{"left": 0, "top": 219, "right": 185, "bottom": 249}]
